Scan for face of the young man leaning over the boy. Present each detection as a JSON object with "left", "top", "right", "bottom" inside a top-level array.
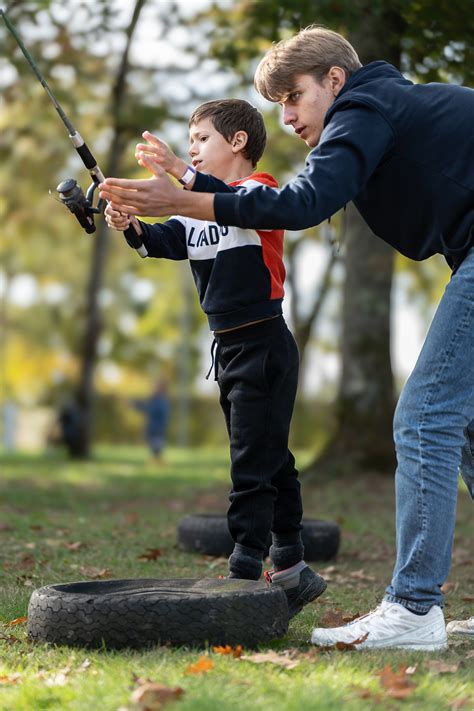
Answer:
[{"left": 280, "top": 69, "right": 344, "bottom": 148}]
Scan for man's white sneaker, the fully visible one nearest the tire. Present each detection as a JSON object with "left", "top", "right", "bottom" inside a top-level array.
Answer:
[{"left": 311, "top": 600, "right": 448, "bottom": 652}]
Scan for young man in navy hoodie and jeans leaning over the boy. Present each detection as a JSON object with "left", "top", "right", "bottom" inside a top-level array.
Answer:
[{"left": 104, "top": 27, "right": 474, "bottom": 650}]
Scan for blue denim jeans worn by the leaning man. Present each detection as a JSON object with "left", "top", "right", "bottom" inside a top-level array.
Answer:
[{"left": 385, "top": 248, "right": 474, "bottom": 612}]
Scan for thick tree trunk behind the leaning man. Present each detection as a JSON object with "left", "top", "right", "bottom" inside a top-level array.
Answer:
[{"left": 305, "top": 6, "right": 403, "bottom": 477}]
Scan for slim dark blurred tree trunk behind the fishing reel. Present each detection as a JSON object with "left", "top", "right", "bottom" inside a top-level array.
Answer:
[{"left": 68, "top": 0, "right": 146, "bottom": 459}]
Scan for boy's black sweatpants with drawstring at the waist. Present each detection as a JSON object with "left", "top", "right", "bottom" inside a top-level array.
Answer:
[{"left": 215, "top": 316, "right": 303, "bottom": 578}]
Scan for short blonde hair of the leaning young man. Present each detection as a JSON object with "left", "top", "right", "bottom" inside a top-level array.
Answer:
[{"left": 255, "top": 25, "right": 362, "bottom": 101}]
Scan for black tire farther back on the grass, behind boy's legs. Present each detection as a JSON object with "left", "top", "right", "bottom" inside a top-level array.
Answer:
[{"left": 178, "top": 514, "right": 341, "bottom": 561}]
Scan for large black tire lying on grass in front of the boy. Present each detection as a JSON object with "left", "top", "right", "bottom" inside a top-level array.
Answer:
[{"left": 28, "top": 578, "right": 288, "bottom": 649}]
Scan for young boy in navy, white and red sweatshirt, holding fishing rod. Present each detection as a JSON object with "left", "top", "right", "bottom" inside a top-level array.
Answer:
[{"left": 105, "top": 99, "right": 326, "bottom": 617}]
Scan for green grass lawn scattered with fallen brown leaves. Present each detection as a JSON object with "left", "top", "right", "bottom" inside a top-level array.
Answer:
[{"left": 0, "top": 448, "right": 474, "bottom": 711}]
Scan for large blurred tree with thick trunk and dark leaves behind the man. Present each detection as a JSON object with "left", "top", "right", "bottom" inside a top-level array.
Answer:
[{"left": 196, "top": 0, "right": 474, "bottom": 476}]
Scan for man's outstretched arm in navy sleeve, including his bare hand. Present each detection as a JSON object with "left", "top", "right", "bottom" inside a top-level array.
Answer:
[{"left": 101, "top": 106, "right": 394, "bottom": 230}]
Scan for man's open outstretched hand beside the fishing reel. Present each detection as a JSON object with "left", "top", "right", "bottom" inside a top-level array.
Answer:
[{"left": 99, "top": 165, "right": 183, "bottom": 217}]
